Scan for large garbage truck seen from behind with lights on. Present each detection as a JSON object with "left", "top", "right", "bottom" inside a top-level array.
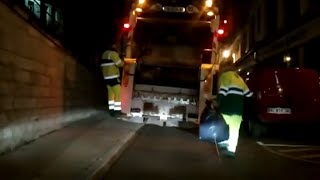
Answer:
[{"left": 120, "top": 0, "right": 220, "bottom": 127}]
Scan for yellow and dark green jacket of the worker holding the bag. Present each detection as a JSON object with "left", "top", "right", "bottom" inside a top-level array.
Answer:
[{"left": 217, "top": 71, "right": 253, "bottom": 115}]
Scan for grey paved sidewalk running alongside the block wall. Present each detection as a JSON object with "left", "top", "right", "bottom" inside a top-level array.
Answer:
[{"left": 0, "top": 113, "right": 143, "bottom": 180}]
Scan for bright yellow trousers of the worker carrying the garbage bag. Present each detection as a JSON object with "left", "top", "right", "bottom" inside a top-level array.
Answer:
[{"left": 222, "top": 114, "right": 242, "bottom": 152}]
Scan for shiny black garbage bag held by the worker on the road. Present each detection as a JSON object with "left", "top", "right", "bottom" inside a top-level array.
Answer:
[{"left": 199, "top": 101, "right": 229, "bottom": 142}]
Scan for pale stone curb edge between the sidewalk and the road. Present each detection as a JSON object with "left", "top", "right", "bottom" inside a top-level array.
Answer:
[{"left": 85, "top": 125, "right": 143, "bottom": 180}]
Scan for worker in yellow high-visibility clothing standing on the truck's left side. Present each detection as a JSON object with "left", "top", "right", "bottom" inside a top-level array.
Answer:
[{"left": 100, "top": 44, "right": 124, "bottom": 116}]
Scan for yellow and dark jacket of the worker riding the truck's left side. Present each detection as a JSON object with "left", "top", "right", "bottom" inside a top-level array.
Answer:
[{"left": 100, "top": 50, "right": 123, "bottom": 79}]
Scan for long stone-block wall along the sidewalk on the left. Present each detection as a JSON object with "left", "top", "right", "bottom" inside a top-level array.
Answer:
[{"left": 0, "top": 2, "right": 104, "bottom": 153}]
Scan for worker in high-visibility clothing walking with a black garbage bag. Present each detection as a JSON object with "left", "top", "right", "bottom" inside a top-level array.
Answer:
[{"left": 217, "top": 59, "right": 253, "bottom": 157}]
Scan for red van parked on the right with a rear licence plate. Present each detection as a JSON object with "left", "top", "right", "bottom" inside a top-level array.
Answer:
[{"left": 244, "top": 68, "right": 320, "bottom": 137}]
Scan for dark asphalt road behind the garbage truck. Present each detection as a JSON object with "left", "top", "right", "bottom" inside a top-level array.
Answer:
[{"left": 104, "top": 125, "right": 320, "bottom": 180}]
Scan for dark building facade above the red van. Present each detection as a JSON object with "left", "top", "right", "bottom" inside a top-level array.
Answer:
[{"left": 219, "top": 0, "right": 320, "bottom": 71}]
